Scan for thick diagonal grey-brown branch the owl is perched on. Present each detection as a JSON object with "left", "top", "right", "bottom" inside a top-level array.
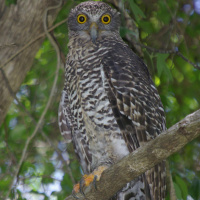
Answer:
[{"left": 66, "top": 110, "right": 200, "bottom": 200}]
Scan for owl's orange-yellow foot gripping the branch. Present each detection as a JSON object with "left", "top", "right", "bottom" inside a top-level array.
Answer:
[{"left": 73, "top": 166, "right": 108, "bottom": 195}]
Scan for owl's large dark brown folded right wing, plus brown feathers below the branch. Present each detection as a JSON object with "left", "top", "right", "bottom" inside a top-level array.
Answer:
[{"left": 102, "top": 44, "right": 165, "bottom": 199}]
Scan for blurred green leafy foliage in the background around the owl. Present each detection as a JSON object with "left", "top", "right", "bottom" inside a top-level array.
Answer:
[{"left": 0, "top": 0, "right": 200, "bottom": 200}]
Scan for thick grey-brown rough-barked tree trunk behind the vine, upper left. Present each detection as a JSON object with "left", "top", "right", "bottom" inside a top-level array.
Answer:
[{"left": 0, "top": 0, "right": 63, "bottom": 125}]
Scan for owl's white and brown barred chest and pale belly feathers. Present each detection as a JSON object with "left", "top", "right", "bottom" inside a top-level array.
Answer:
[{"left": 66, "top": 38, "right": 129, "bottom": 170}]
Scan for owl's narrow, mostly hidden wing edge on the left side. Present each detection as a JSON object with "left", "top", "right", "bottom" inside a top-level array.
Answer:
[{"left": 58, "top": 88, "right": 72, "bottom": 143}]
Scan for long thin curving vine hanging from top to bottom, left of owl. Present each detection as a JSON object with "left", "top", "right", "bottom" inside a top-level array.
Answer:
[{"left": 6, "top": 0, "right": 62, "bottom": 199}]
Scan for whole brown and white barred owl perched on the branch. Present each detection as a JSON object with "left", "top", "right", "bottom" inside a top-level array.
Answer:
[{"left": 59, "top": 1, "right": 166, "bottom": 200}]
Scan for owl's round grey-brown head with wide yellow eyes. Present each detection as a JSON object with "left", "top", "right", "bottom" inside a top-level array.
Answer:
[{"left": 68, "top": 1, "right": 120, "bottom": 43}]
